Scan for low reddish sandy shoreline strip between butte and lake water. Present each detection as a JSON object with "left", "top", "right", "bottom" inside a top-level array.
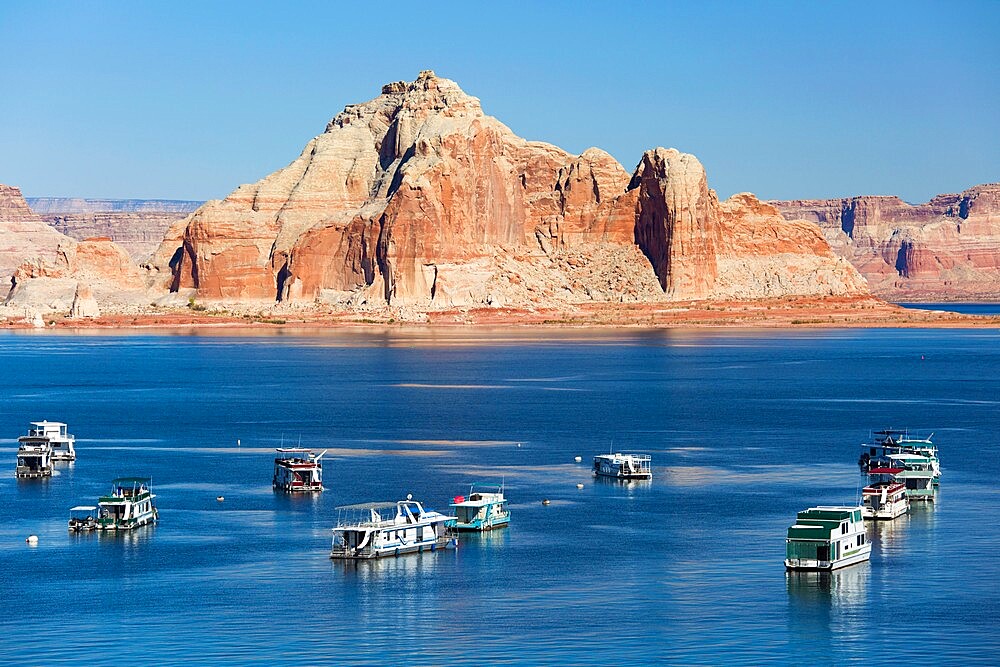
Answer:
[{"left": 0, "top": 297, "right": 1000, "bottom": 331}]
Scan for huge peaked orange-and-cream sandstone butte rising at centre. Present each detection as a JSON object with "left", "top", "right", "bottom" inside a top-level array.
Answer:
[{"left": 148, "top": 71, "right": 868, "bottom": 316}]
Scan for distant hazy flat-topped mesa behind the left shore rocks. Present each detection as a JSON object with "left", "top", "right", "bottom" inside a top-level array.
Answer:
[{"left": 27, "top": 197, "right": 202, "bottom": 262}]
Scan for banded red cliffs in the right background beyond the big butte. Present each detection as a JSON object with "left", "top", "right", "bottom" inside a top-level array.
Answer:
[{"left": 773, "top": 183, "right": 1000, "bottom": 300}]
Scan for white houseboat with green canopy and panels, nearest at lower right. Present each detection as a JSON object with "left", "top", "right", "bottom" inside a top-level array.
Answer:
[{"left": 785, "top": 506, "right": 872, "bottom": 570}]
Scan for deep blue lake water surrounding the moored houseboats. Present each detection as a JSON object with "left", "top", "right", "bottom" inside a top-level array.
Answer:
[{"left": 0, "top": 330, "right": 1000, "bottom": 665}]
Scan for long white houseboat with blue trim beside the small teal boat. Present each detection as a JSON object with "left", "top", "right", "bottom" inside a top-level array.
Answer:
[{"left": 330, "top": 496, "right": 458, "bottom": 560}]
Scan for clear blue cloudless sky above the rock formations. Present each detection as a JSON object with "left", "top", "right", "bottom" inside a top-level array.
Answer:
[{"left": 0, "top": 0, "right": 1000, "bottom": 202}]
